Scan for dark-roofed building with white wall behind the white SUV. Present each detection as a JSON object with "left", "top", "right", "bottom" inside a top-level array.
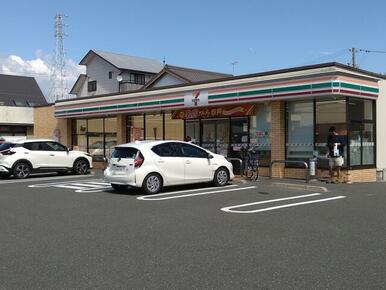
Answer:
[{"left": 0, "top": 74, "right": 47, "bottom": 140}]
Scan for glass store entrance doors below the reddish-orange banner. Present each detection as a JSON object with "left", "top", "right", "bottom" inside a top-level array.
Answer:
[{"left": 201, "top": 119, "right": 229, "bottom": 156}]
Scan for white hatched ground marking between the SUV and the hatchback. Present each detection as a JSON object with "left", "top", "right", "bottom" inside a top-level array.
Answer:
[{"left": 28, "top": 179, "right": 111, "bottom": 193}]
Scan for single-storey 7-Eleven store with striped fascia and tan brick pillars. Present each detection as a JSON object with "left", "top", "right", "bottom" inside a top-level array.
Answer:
[{"left": 34, "top": 49, "right": 386, "bottom": 181}]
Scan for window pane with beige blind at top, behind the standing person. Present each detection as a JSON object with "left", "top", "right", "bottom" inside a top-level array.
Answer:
[{"left": 315, "top": 97, "right": 347, "bottom": 168}]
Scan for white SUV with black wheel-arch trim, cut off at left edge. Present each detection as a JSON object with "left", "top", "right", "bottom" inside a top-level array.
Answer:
[{"left": 0, "top": 139, "right": 92, "bottom": 178}]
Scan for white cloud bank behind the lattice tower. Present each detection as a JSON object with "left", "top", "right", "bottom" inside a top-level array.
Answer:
[{"left": 0, "top": 50, "right": 84, "bottom": 100}]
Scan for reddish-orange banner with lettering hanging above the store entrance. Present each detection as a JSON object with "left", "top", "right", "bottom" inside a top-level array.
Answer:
[{"left": 172, "top": 104, "right": 254, "bottom": 120}]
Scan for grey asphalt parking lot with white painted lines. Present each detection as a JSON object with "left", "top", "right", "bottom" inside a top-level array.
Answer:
[{"left": 0, "top": 174, "right": 386, "bottom": 289}]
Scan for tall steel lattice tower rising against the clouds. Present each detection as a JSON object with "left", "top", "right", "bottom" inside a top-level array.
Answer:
[{"left": 48, "top": 13, "right": 68, "bottom": 102}]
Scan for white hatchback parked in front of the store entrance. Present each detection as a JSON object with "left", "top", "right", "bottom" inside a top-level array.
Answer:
[{"left": 104, "top": 141, "right": 234, "bottom": 194}]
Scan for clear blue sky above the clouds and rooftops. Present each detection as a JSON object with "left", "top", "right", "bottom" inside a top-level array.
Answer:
[{"left": 0, "top": 0, "right": 386, "bottom": 74}]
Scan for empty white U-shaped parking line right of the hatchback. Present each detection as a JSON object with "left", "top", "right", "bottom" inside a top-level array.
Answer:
[{"left": 221, "top": 193, "right": 346, "bottom": 213}]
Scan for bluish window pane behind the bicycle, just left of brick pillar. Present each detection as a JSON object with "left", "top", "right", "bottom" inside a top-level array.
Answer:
[{"left": 249, "top": 103, "right": 271, "bottom": 166}]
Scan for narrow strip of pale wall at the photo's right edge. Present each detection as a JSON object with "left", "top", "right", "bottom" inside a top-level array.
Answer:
[{"left": 376, "top": 80, "right": 386, "bottom": 170}]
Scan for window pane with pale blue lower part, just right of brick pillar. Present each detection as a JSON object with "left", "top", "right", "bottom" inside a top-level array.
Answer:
[{"left": 286, "top": 101, "right": 314, "bottom": 161}]
